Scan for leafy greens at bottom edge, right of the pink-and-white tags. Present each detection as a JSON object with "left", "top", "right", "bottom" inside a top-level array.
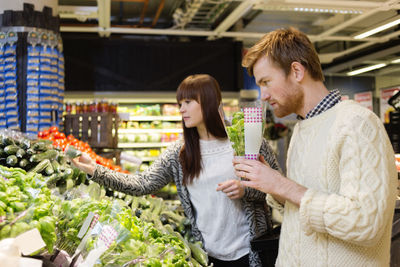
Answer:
[{"left": 86, "top": 204, "right": 190, "bottom": 267}]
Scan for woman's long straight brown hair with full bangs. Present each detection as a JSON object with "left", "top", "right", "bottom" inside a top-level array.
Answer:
[{"left": 176, "top": 74, "right": 227, "bottom": 185}]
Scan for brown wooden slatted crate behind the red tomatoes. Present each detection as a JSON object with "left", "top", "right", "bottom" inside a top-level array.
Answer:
[{"left": 64, "top": 112, "right": 119, "bottom": 148}]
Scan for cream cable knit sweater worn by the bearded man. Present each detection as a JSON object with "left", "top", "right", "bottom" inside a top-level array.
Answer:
[{"left": 268, "top": 101, "right": 397, "bottom": 267}]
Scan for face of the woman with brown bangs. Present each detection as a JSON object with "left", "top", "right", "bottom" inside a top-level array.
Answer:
[{"left": 179, "top": 99, "right": 204, "bottom": 128}]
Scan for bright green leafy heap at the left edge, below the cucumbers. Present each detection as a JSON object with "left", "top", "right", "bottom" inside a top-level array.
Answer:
[{"left": 0, "top": 166, "right": 58, "bottom": 253}]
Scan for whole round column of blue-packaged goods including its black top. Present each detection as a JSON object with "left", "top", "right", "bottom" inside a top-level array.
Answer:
[{"left": 0, "top": 4, "right": 64, "bottom": 135}]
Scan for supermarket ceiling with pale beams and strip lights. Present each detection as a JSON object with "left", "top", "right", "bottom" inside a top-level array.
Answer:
[{"left": 58, "top": 0, "right": 400, "bottom": 76}]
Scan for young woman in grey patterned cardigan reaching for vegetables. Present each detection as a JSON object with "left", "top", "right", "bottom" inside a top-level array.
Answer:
[{"left": 73, "top": 74, "right": 279, "bottom": 267}]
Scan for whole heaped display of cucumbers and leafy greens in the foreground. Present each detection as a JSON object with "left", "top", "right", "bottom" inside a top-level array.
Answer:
[{"left": 0, "top": 131, "right": 208, "bottom": 267}]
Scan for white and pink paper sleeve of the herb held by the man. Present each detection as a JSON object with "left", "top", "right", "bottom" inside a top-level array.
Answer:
[{"left": 243, "top": 107, "right": 263, "bottom": 160}]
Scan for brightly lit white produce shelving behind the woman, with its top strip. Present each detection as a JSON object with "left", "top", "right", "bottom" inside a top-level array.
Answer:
[{"left": 65, "top": 91, "right": 239, "bottom": 172}]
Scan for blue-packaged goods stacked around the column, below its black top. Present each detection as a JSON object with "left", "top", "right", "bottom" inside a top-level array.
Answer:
[{"left": 0, "top": 31, "right": 64, "bottom": 135}]
